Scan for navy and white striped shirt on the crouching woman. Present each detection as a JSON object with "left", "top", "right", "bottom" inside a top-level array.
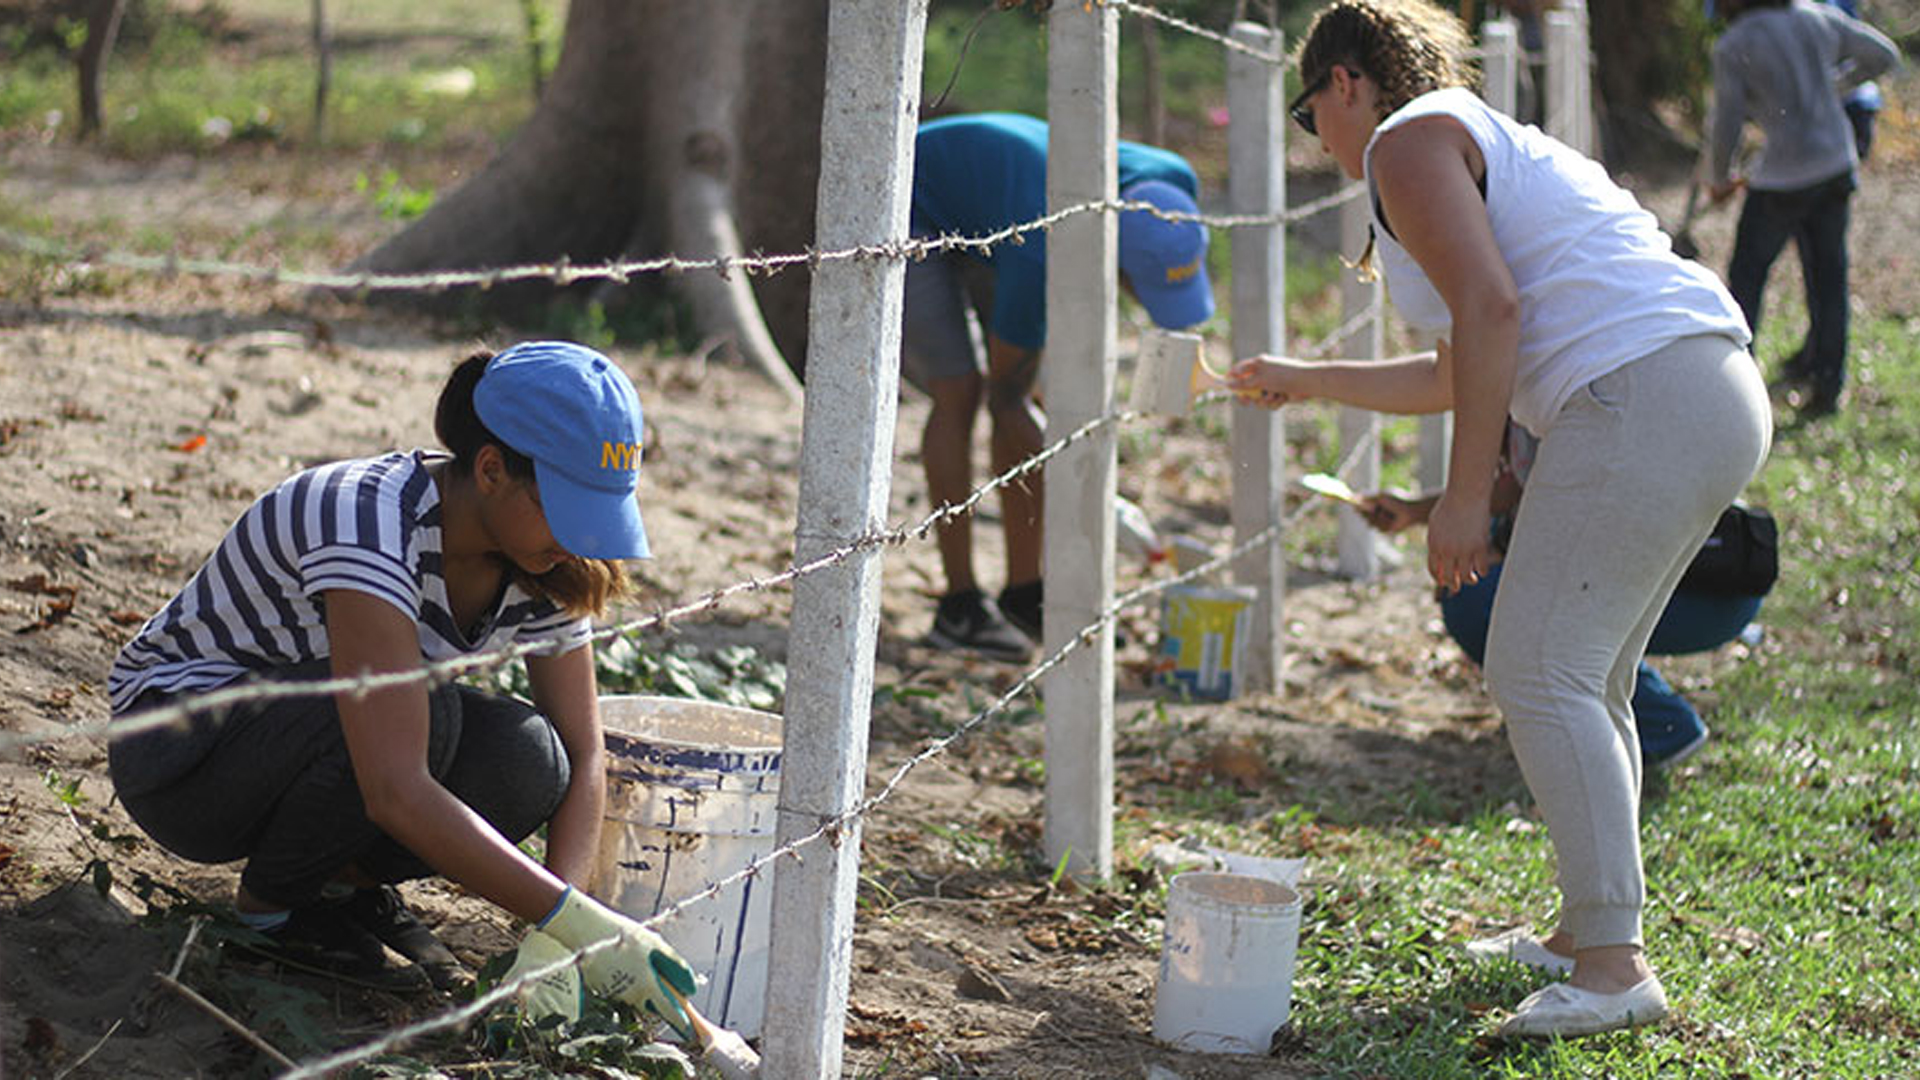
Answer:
[{"left": 108, "top": 450, "right": 589, "bottom": 713}]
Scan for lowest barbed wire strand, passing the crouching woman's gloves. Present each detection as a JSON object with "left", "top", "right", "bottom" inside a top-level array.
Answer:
[{"left": 278, "top": 418, "right": 1377, "bottom": 1080}]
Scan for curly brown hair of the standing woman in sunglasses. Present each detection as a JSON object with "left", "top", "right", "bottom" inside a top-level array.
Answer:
[{"left": 1294, "top": 0, "right": 1476, "bottom": 117}]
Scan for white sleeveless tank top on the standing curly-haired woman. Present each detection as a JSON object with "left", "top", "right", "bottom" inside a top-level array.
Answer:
[{"left": 1365, "top": 86, "right": 1753, "bottom": 436}]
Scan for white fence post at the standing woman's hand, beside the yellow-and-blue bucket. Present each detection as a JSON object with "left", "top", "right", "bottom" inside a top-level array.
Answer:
[{"left": 1227, "top": 23, "right": 1286, "bottom": 694}]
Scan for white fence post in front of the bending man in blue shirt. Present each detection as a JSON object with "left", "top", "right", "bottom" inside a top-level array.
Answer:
[{"left": 1029, "top": 4, "right": 1119, "bottom": 878}]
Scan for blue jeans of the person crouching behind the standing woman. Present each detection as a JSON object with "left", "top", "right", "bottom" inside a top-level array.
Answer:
[{"left": 1440, "top": 563, "right": 1763, "bottom": 746}]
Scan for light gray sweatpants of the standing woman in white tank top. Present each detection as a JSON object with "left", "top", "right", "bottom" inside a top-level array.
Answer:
[{"left": 1486, "top": 336, "right": 1772, "bottom": 949}]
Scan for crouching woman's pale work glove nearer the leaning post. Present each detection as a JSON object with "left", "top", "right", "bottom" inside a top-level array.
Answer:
[{"left": 540, "top": 886, "right": 697, "bottom": 1040}]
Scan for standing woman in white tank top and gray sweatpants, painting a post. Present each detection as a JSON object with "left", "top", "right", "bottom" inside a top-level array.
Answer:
[{"left": 1231, "top": 0, "right": 1772, "bottom": 1036}]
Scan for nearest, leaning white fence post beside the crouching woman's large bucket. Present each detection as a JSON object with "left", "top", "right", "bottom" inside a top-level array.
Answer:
[{"left": 760, "top": 0, "right": 927, "bottom": 1080}]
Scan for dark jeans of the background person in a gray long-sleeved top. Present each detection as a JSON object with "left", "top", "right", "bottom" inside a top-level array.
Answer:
[{"left": 1726, "top": 169, "right": 1857, "bottom": 396}]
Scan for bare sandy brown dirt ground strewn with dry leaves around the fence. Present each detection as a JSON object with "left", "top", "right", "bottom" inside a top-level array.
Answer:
[{"left": 0, "top": 69, "right": 1920, "bottom": 1080}]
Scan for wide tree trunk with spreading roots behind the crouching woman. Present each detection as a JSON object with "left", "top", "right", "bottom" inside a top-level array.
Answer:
[{"left": 355, "top": 0, "right": 826, "bottom": 396}]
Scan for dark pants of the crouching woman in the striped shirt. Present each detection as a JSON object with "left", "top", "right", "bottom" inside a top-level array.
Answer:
[{"left": 108, "top": 661, "right": 572, "bottom": 907}]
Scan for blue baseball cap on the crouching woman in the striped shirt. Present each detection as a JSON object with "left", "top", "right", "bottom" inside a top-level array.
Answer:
[{"left": 474, "top": 342, "right": 651, "bottom": 559}]
